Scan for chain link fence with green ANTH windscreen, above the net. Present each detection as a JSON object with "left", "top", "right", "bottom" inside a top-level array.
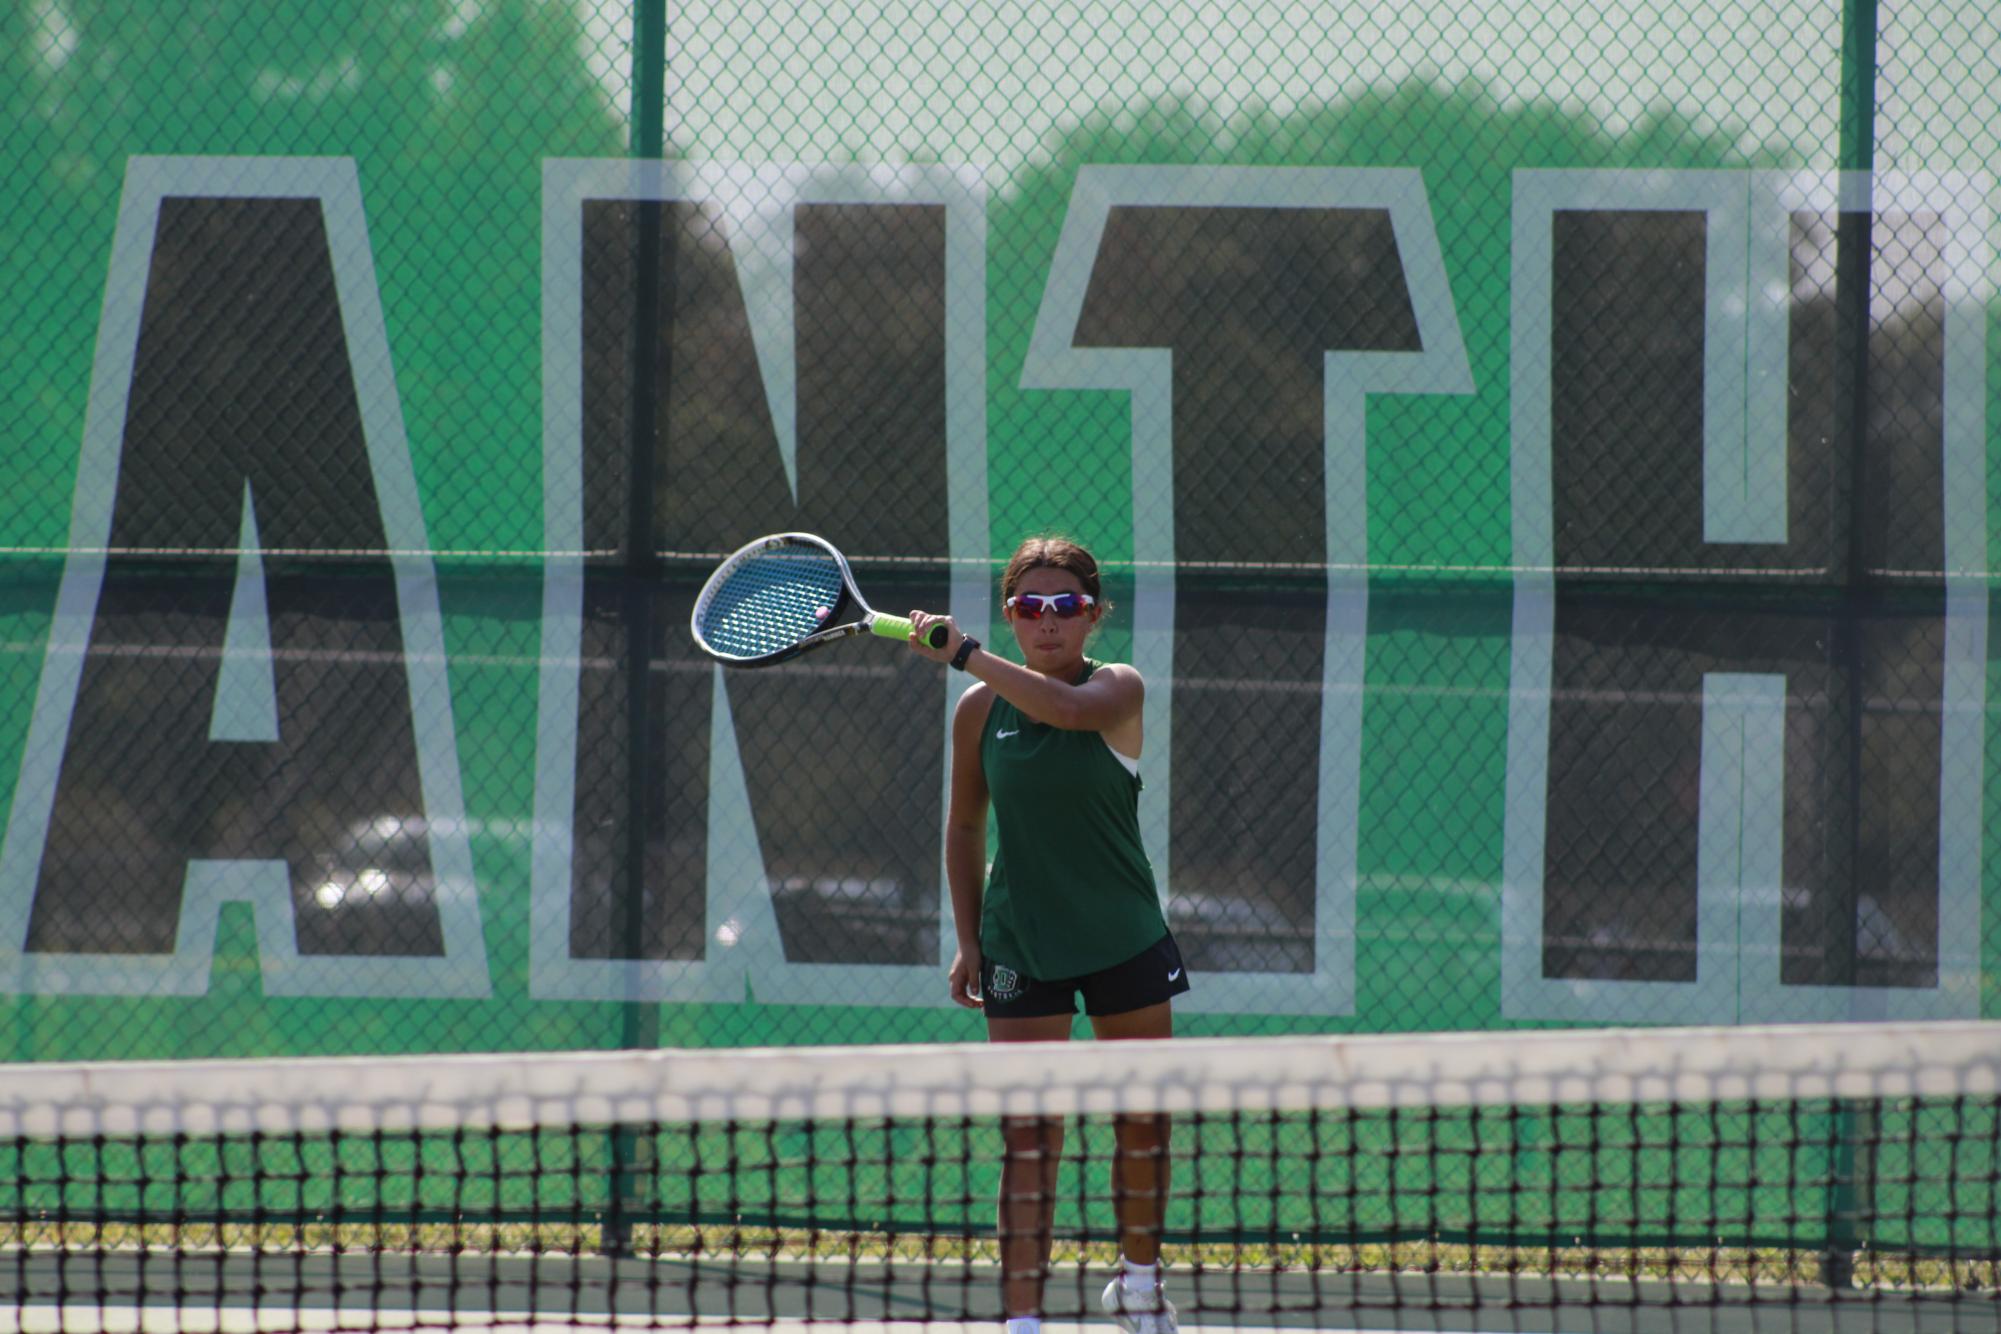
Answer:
[{"left": 0, "top": 0, "right": 2001, "bottom": 1060}]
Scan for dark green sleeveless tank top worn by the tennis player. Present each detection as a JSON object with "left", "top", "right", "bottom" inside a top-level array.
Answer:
[{"left": 980, "top": 660, "right": 1167, "bottom": 980}]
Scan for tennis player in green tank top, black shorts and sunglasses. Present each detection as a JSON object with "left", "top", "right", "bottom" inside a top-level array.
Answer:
[{"left": 910, "top": 536, "right": 1189, "bottom": 1334}]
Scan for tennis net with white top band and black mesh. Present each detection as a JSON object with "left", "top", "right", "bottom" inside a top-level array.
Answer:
[{"left": 0, "top": 1024, "right": 2001, "bottom": 1330}]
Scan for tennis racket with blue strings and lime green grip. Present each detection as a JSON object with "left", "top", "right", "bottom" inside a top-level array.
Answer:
[{"left": 688, "top": 532, "right": 950, "bottom": 666}]
